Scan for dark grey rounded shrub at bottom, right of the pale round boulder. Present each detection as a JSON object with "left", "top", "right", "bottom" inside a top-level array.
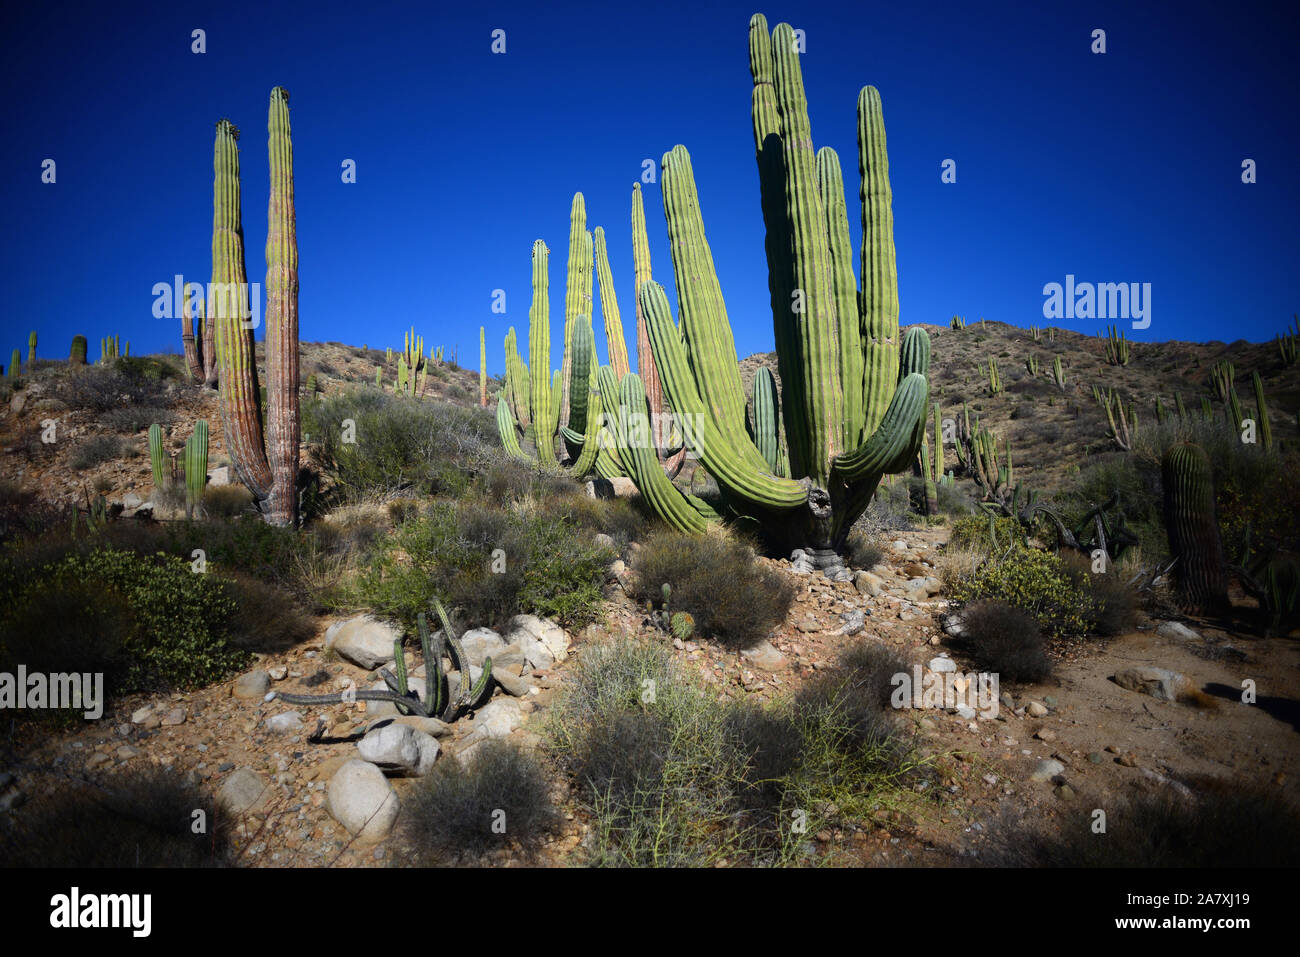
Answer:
[{"left": 402, "top": 740, "right": 562, "bottom": 867}]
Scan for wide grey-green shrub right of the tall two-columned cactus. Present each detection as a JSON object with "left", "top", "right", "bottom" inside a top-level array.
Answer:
[{"left": 303, "top": 389, "right": 501, "bottom": 498}]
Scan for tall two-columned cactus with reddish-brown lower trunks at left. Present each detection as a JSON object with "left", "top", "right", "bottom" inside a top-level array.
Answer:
[{"left": 208, "top": 86, "right": 300, "bottom": 525}]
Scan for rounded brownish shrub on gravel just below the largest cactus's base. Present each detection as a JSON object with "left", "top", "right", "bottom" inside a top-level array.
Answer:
[{"left": 632, "top": 532, "right": 794, "bottom": 648}]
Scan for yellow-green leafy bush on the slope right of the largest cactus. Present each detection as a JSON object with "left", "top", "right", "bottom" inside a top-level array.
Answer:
[{"left": 952, "top": 546, "right": 1095, "bottom": 638}]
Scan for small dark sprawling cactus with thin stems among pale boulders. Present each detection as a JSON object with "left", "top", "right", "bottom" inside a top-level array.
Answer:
[{"left": 276, "top": 598, "right": 491, "bottom": 723}]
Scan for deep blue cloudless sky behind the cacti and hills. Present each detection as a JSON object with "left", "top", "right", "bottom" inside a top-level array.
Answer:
[{"left": 0, "top": 0, "right": 1300, "bottom": 373}]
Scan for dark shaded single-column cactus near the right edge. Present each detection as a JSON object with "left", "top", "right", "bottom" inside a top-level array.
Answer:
[{"left": 1161, "top": 442, "right": 1229, "bottom": 614}]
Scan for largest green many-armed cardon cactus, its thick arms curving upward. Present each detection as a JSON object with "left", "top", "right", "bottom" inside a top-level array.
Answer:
[{"left": 602, "top": 16, "right": 930, "bottom": 579}]
